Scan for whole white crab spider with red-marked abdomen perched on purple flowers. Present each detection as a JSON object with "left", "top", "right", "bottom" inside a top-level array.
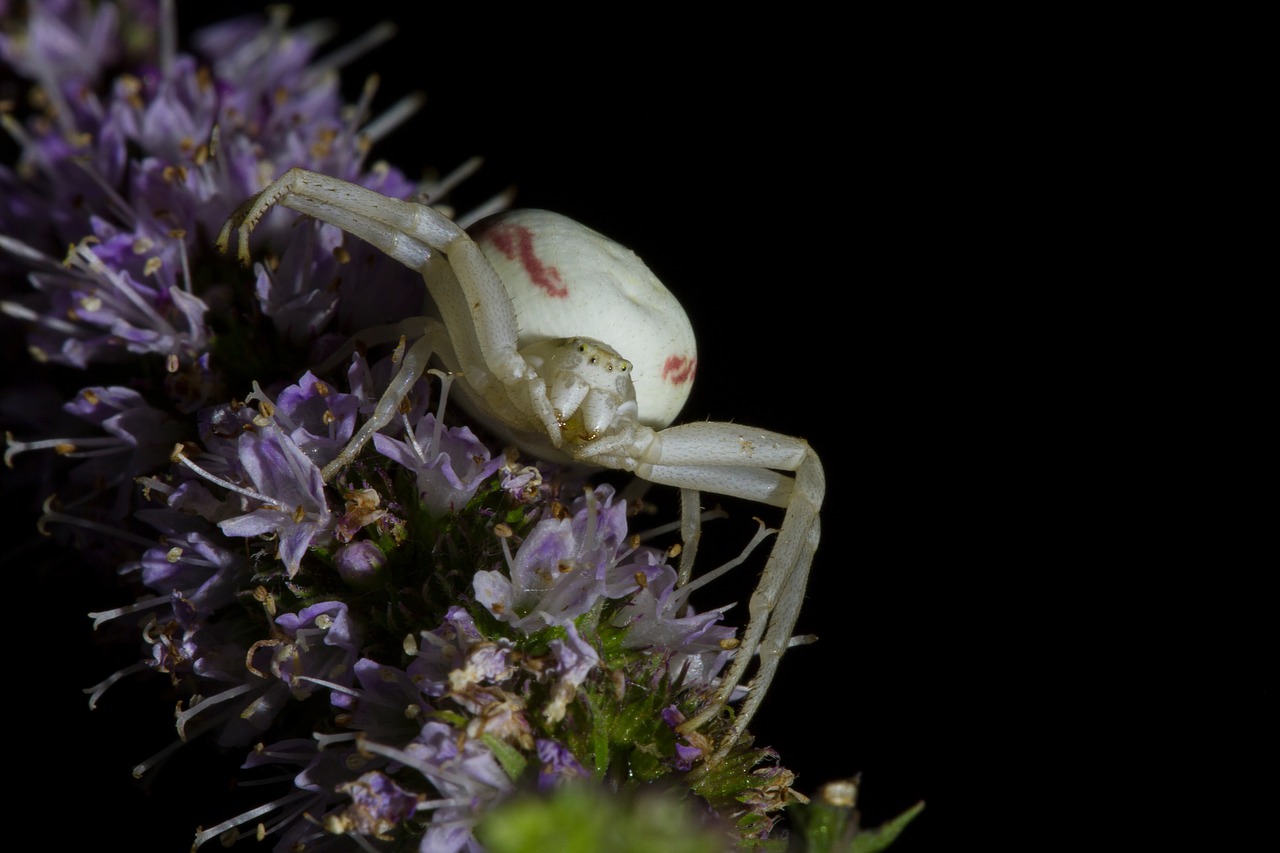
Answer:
[{"left": 218, "top": 169, "right": 826, "bottom": 761}]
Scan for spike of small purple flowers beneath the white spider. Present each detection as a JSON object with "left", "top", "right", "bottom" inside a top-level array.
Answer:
[{"left": 0, "top": 0, "right": 788, "bottom": 852}]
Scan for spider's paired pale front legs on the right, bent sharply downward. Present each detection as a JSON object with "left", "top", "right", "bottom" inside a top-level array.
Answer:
[{"left": 611, "top": 423, "right": 826, "bottom": 763}]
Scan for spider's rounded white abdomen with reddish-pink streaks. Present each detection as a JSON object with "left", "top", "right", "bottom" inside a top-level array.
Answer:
[{"left": 471, "top": 210, "right": 698, "bottom": 430}]
